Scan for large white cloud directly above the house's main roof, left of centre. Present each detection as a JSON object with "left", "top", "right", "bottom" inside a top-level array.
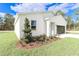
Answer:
[{"left": 11, "top": 3, "right": 46, "bottom": 13}]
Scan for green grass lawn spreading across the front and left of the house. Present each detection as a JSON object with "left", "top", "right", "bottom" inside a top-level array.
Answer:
[{"left": 0, "top": 32, "right": 79, "bottom": 56}]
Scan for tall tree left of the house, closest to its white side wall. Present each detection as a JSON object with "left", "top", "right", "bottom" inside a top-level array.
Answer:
[{"left": 4, "top": 14, "right": 15, "bottom": 30}]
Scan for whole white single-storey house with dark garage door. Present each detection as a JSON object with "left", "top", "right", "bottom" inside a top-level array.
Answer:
[{"left": 14, "top": 12, "right": 67, "bottom": 39}]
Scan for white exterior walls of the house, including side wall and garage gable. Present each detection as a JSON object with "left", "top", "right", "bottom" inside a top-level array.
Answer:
[{"left": 15, "top": 13, "right": 66, "bottom": 38}]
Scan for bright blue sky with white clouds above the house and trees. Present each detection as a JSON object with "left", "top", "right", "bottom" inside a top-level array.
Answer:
[{"left": 0, "top": 3, "right": 79, "bottom": 19}]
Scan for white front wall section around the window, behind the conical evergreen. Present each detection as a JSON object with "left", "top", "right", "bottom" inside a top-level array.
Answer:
[{"left": 19, "top": 14, "right": 45, "bottom": 38}]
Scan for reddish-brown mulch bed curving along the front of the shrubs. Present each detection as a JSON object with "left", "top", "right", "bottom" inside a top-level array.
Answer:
[{"left": 16, "top": 38, "right": 60, "bottom": 49}]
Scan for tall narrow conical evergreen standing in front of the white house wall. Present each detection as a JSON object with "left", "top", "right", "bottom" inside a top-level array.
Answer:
[{"left": 23, "top": 18, "right": 32, "bottom": 42}]
